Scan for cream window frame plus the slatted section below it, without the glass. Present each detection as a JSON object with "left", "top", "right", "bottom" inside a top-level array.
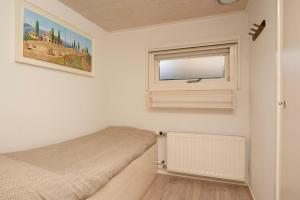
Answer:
[{"left": 147, "top": 36, "right": 240, "bottom": 109}]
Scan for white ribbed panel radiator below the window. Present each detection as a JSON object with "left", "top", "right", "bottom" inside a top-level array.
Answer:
[{"left": 167, "top": 132, "right": 246, "bottom": 182}]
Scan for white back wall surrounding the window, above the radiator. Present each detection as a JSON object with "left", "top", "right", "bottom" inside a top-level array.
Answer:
[{"left": 106, "top": 12, "right": 249, "bottom": 136}]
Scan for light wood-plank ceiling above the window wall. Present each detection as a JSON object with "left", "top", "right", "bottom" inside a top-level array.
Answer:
[{"left": 60, "top": 0, "right": 247, "bottom": 31}]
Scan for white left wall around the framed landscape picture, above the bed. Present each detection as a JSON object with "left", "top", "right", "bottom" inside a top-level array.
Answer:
[{"left": 0, "top": 0, "right": 106, "bottom": 152}]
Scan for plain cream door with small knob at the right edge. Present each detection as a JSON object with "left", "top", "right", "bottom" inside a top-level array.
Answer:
[{"left": 281, "top": 0, "right": 300, "bottom": 200}]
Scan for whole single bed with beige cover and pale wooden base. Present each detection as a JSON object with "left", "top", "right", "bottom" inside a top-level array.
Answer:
[{"left": 0, "top": 127, "right": 156, "bottom": 200}]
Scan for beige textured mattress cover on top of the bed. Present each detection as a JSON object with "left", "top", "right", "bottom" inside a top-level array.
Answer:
[{"left": 0, "top": 127, "right": 156, "bottom": 200}]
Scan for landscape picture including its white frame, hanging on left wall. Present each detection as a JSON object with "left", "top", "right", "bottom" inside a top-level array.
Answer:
[{"left": 16, "top": 0, "right": 95, "bottom": 76}]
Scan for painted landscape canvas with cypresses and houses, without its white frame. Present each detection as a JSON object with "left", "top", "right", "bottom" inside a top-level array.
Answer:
[{"left": 16, "top": 0, "right": 93, "bottom": 74}]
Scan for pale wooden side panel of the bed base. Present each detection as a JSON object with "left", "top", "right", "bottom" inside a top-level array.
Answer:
[{"left": 87, "top": 144, "right": 157, "bottom": 200}]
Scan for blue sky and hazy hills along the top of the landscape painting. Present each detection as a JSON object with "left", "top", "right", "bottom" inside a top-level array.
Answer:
[{"left": 24, "top": 8, "right": 92, "bottom": 53}]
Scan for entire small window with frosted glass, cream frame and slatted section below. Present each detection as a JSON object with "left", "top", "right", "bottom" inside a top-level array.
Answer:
[{"left": 148, "top": 40, "right": 238, "bottom": 108}]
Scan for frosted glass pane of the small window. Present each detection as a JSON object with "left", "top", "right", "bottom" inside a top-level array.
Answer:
[{"left": 159, "top": 55, "right": 225, "bottom": 80}]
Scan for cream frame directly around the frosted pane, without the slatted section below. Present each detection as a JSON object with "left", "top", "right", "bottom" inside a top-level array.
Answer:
[{"left": 148, "top": 40, "right": 239, "bottom": 91}]
